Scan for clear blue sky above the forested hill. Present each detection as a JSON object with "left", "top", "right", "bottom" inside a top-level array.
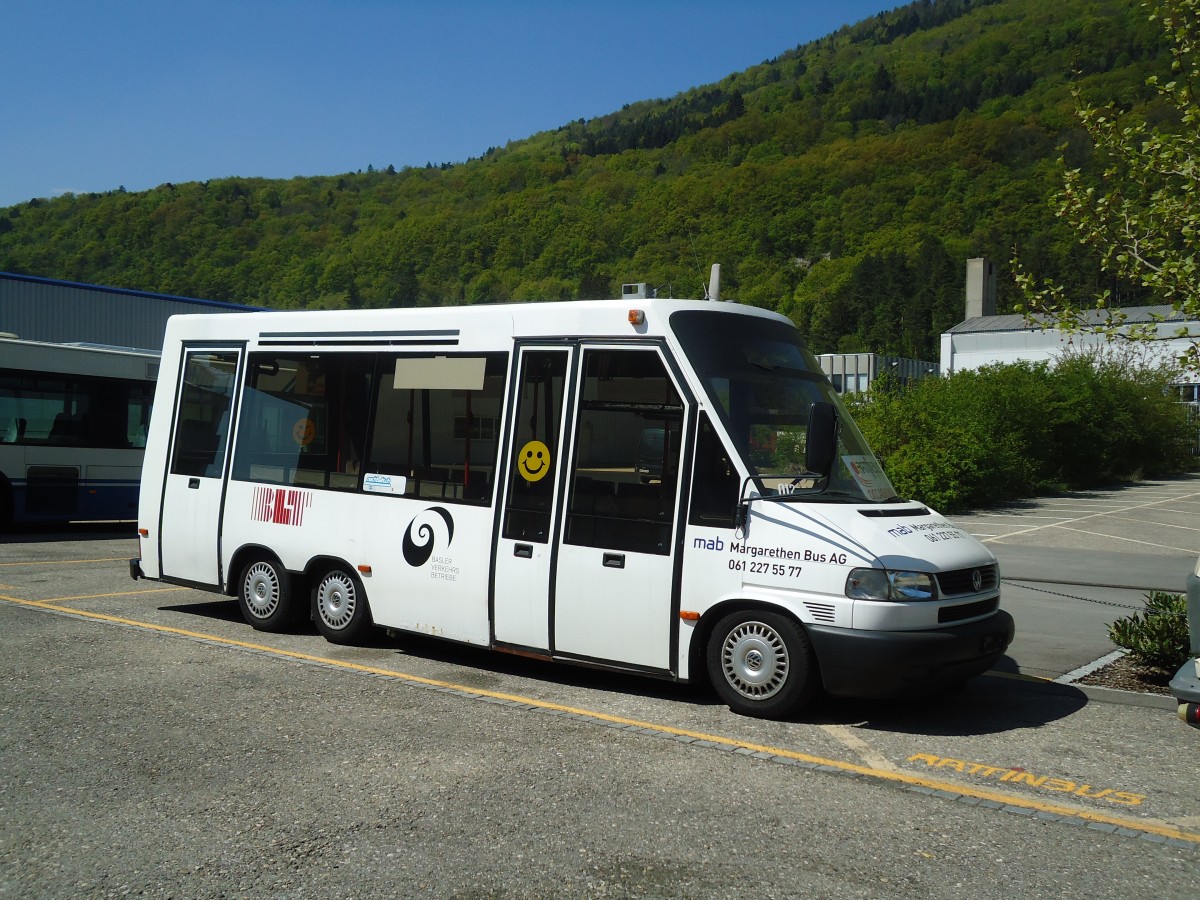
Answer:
[{"left": 0, "top": 0, "right": 901, "bottom": 206}]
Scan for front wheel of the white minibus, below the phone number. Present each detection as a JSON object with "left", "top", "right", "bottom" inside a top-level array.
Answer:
[{"left": 708, "top": 610, "right": 820, "bottom": 719}]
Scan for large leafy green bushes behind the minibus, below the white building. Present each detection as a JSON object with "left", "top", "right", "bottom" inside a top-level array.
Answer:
[{"left": 853, "top": 347, "right": 1195, "bottom": 512}]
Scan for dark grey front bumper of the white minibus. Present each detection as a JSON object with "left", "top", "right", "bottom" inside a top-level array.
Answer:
[{"left": 806, "top": 610, "right": 1014, "bottom": 697}]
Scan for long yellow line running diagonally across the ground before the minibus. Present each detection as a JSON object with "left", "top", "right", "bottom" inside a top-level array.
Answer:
[{"left": 0, "top": 595, "right": 1200, "bottom": 844}]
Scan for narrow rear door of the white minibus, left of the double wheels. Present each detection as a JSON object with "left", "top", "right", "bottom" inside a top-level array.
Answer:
[{"left": 158, "top": 348, "right": 242, "bottom": 586}]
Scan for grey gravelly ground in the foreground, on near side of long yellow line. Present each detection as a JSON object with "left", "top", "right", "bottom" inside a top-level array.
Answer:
[{"left": 0, "top": 604, "right": 1200, "bottom": 900}]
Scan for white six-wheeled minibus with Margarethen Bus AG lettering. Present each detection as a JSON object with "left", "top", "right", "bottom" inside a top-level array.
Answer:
[{"left": 130, "top": 298, "right": 1013, "bottom": 718}]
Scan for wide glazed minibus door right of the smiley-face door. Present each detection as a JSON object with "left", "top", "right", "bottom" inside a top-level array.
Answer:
[{"left": 553, "top": 347, "right": 685, "bottom": 671}]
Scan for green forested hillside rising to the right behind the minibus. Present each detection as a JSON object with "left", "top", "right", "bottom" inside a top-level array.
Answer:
[{"left": 0, "top": 0, "right": 1169, "bottom": 359}]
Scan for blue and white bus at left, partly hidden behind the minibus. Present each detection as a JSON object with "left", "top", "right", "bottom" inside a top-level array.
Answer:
[{"left": 0, "top": 337, "right": 158, "bottom": 528}]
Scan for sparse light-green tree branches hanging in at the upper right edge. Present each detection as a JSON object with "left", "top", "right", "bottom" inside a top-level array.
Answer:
[{"left": 1014, "top": 0, "right": 1200, "bottom": 362}]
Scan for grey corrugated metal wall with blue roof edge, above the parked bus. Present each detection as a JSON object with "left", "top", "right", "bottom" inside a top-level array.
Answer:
[{"left": 0, "top": 272, "right": 253, "bottom": 353}]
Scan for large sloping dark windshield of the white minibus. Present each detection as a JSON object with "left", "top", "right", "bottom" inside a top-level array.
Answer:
[{"left": 671, "top": 308, "right": 896, "bottom": 503}]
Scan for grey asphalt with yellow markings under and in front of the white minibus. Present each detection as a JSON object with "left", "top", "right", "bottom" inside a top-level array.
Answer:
[{"left": 0, "top": 491, "right": 1200, "bottom": 898}]
